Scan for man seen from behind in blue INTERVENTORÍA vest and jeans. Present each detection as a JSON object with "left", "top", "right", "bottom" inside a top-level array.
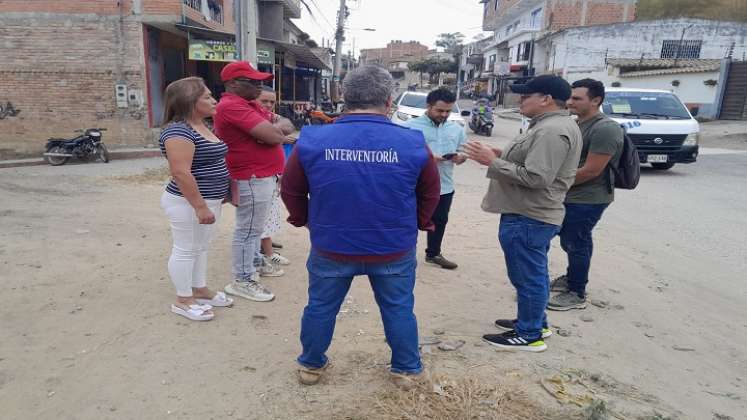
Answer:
[{"left": 281, "top": 66, "right": 440, "bottom": 387}]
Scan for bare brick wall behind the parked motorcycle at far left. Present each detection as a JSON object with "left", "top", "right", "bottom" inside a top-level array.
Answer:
[{"left": 0, "top": 13, "right": 150, "bottom": 158}]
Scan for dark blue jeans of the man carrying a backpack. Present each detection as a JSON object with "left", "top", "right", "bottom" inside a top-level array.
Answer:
[{"left": 560, "top": 203, "right": 609, "bottom": 297}]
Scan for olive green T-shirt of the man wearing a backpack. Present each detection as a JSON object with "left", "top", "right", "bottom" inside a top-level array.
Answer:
[{"left": 565, "top": 113, "right": 624, "bottom": 204}]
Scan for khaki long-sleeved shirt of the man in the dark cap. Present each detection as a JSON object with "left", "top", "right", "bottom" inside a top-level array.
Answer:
[{"left": 482, "top": 111, "right": 581, "bottom": 226}]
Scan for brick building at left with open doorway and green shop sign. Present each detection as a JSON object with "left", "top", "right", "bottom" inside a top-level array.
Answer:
[{"left": 0, "top": 0, "right": 324, "bottom": 159}]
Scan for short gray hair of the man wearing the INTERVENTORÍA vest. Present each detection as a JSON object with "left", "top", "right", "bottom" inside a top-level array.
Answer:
[{"left": 342, "top": 65, "right": 394, "bottom": 110}]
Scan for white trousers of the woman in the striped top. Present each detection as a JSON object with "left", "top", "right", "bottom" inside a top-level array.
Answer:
[{"left": 161, "top": 192, "right": 223, "bottom": 297}]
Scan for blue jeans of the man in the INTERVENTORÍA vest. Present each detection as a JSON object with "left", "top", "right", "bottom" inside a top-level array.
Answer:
[{"left": 298, "top": 249, "right": 423, "bottom": 374}]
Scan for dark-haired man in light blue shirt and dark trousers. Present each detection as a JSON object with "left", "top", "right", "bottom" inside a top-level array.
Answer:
[{"left": 405, "top": 88, "right": 467, "bottom": 270}]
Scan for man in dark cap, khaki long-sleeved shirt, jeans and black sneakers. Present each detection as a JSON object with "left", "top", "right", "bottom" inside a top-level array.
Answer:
[{"left": 465, "top": 75, "right": 582, "bottom": 352}]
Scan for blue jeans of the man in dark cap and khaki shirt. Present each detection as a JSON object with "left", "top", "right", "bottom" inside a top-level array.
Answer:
[{"left": 498, "top": 214, "right": 560, "bottom": 341}]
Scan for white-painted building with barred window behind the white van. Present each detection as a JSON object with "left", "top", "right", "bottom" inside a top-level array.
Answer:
[{"left": 535, "top": 19, "right": 747, "bottom": 118}]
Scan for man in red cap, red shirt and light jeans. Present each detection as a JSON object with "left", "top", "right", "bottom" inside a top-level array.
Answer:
[{"left": 215, "top": 61, "right": 285, "bottom": 302}]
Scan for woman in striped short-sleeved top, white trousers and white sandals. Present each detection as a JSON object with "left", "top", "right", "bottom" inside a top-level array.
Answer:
[{"left": 159, "top": 77, "right": 233, "bottom": 321}]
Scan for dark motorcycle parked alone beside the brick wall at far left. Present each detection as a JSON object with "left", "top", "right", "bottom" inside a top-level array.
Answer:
[{"left": 44, "top": 128, "right": 109, "bottom": 166}]
